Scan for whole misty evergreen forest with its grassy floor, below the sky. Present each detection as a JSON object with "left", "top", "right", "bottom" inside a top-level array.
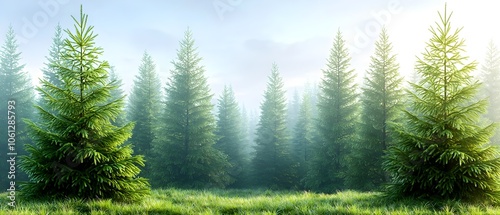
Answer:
[{"left": 0, "top": 2, "right": 500, "bottom": 214}]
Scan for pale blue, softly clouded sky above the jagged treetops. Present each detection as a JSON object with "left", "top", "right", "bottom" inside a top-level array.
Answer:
[{"left": 0, "top": 0, "right": 500, "bottom": 111}]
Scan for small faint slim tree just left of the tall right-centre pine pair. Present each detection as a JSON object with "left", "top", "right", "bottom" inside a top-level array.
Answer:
[{"left": 292, "top": 92, "right": 313, "bottom": 188}]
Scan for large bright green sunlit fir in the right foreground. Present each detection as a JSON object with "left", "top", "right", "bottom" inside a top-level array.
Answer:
[{"left": 384, "top": 7, "right": 500, "bottom": 202}]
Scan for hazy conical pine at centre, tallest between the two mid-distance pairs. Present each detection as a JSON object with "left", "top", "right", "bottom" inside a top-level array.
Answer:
[{"left": 252, "top": 64, "right": 293, "bottom": 189}]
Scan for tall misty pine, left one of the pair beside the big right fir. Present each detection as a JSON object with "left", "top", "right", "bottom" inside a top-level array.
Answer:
[{"left": 306, "top": 31, "right": 358, "bottom": 192}]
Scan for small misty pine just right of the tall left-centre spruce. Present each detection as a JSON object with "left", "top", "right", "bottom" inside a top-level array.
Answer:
[{"left": 215, "top": 86, "right": 246, "bottom": 187}]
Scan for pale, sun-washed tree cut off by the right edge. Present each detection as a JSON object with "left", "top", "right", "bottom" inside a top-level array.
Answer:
[{"left": 481, "top": 41, "right": 500, "bottom": 144}]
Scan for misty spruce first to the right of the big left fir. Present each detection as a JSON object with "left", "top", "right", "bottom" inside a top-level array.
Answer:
[{"left": 127, "top": 52, "right": 161, "bottom": 177}]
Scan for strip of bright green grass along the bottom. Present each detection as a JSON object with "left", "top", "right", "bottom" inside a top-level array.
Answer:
[{"left": 0, "top": 189, "right": 500, "bottom": 215}]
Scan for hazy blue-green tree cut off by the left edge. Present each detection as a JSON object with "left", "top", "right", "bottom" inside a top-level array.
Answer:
[{"left": 0, "top": 26, "right": 34, "bottom": 186}]
